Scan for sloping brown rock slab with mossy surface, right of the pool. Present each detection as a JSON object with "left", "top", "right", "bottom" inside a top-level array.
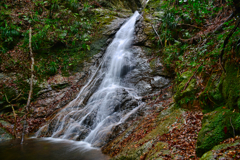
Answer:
[{"left": 102, "top": 104, "right": 188, "bottom": 159}]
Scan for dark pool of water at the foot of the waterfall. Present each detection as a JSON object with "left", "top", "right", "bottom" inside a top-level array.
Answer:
[{"left": 0, "top": 138, "right": 108, "bottom": 160}]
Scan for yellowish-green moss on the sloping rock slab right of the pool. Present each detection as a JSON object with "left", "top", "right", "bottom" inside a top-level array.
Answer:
[{"left": 104, "top": 105, "right": 184, "bottom": 159}]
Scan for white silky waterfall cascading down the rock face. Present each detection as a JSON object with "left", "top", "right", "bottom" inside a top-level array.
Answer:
[{"left": 37, "top": 12, "right": 141, "bottom": 146}]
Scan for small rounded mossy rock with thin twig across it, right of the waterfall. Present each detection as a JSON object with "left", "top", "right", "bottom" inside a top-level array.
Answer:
[{"left": 174, "top": 71, "right": 197, "bottom": 106}]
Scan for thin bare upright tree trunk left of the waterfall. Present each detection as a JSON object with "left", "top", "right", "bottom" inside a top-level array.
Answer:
[{"left": 21, "top": 27, "right": 34, "bottom": 144}]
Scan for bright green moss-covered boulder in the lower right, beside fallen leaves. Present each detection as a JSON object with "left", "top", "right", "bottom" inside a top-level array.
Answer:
[{"left": 196, "top": 107, "right": 240, "bottom": 157}]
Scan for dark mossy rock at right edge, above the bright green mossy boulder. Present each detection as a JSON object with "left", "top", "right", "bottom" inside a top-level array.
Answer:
[{"left": 199, "top": 62, "right": 240, "bottom": 112}]
